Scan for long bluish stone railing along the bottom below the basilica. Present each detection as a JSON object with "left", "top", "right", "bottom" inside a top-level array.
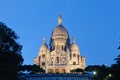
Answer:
[{"left": 19, "top": 74, "right": 92, "bottom": 80}]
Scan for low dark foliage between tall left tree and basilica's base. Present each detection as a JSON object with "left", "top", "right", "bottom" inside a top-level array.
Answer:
[{"left": 19, "top": 65, "right": 45, "bottom": 74}]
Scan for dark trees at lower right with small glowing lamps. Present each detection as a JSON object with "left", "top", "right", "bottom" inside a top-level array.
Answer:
[{"left": 85, "top": 43, "right": 120, "bottom": 80}]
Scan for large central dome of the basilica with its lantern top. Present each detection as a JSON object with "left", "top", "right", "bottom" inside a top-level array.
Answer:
[{"left": 52, "top": 16, "right": 68, "bottom": 37}]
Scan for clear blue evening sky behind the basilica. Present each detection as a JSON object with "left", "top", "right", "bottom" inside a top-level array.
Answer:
[{"left": 0, "top": 0, "right": 120, "bottom": 65}]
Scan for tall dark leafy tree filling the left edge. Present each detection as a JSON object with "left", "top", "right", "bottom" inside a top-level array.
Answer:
[{"left": 0, "top": 22, "right": 23, "bottom": 80}]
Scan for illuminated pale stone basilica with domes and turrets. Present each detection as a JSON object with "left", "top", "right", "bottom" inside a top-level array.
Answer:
[{"left": 34, "top": 16, "right": 86, "bottom": 73}]
